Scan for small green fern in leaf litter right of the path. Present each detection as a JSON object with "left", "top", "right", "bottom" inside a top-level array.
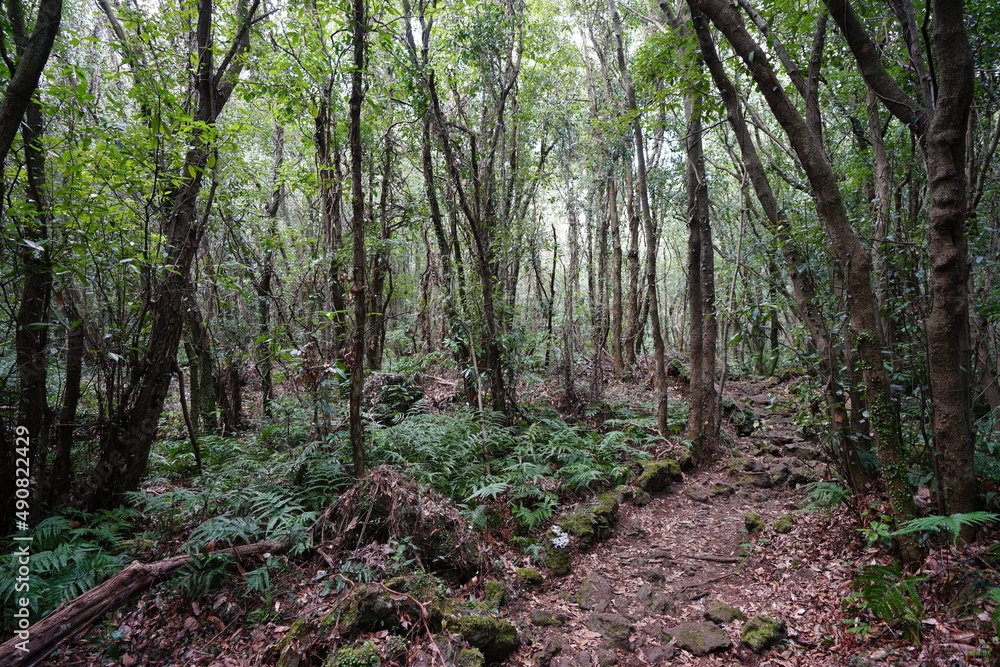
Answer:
[{"left": 848, "top": 563, "right": 926, "bottom": 641}]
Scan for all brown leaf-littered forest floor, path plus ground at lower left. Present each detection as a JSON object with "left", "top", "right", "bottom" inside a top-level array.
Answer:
[{"left": 35, "top": 381, "right": 1000, "bottom": 667}]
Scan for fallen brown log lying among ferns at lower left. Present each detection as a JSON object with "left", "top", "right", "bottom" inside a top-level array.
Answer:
[{"left": 0, "top": 540, "right": 288, "bottom": 667}]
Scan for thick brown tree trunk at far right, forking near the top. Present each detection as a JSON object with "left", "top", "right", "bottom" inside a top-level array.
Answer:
[{"left": 825, "top": 0, "right": 982, "bottom": 537}]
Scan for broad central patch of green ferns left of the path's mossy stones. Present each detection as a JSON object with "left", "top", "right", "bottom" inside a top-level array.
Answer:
[{"left": 371, "top": 411, "right": 645, "bottom": 530}]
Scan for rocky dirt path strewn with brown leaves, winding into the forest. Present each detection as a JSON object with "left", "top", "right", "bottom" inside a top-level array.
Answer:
[{"left": 505, "top": 385, "right": 852, "bottom": 667}]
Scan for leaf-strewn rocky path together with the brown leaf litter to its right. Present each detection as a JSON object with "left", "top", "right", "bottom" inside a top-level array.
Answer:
[{"left": 507, "top": 382, "right": 989, "bottom": 667}]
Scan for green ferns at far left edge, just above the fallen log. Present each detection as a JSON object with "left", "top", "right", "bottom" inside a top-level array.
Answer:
[{"left": 0, "top": 508, "right": 135, "bottom": 633}]
